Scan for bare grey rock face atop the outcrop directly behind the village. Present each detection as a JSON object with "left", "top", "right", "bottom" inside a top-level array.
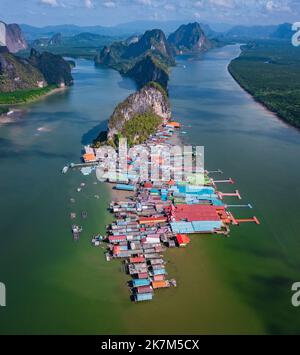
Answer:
[{"left": 108, "top": 83, "right": 171, "bottom": 139}]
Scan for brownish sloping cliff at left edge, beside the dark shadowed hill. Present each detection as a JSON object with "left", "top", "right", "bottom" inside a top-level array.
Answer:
[{"left": 0, "top": 47, "right": 47, "bottom": 92}]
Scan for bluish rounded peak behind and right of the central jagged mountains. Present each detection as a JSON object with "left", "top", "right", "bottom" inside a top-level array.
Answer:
[{"left": 168, "top": 22, "right": 212, "bottom": 54}]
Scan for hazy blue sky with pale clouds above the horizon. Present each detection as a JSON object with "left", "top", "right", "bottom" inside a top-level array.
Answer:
[{"left": 0, "top": 0, "right": 300, "bottom": 26}]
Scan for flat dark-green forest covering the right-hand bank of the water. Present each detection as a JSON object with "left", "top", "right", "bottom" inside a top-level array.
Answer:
[{"left": 229, "top": 41, "right": 300, "bottom": 128}]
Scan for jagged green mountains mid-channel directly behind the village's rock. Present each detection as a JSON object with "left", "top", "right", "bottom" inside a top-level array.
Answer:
[{"left": 95, "top": 22, "right": 213, "bottom": 88}]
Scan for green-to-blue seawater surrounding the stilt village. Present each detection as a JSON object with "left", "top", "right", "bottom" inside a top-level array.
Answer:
[{"left": 0, "top": 46, "right": 300, "bottom": 334}]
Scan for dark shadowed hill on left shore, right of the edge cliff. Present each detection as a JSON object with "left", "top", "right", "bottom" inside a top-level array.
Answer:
[{"left": 29, "top": 49, "right": 73, "bottom": 86}]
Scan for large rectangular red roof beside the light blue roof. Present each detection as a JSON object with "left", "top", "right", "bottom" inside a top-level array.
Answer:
[{"left": 171, "top": 205, "right": 224, "bottom": 222}]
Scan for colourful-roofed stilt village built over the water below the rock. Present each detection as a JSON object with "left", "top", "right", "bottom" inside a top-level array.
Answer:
[{"left": 67, "top": 122, "right": 260, "bottom": 302}]
